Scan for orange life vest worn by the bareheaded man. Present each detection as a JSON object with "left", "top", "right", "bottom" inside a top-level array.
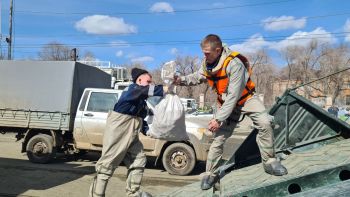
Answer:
[{"left": 204, "top": 52, "right": 255, "bottom": 106}]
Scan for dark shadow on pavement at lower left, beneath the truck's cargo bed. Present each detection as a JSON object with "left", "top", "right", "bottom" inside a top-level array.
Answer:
[{"left": 0, "top": 158, "right": 94, "bottom": 196}]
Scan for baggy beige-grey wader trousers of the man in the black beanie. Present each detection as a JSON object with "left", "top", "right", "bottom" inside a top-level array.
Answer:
[{"left": 89, "top": 111, "right": 146, "bottom": 197}]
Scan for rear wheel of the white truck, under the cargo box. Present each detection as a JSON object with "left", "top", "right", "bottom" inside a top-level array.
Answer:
[{"left": 27, "top": 134, "right": 56, "bottom": 163}]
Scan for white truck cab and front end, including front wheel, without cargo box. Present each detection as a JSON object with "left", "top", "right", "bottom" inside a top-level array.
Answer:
[{"left": 73, "top": 88, "right": 211, "bottom": 175}]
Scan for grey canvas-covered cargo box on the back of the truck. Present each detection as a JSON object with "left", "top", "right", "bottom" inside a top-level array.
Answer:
[{"left": 0, "top": 60, "right": 111, "bottom": 130}]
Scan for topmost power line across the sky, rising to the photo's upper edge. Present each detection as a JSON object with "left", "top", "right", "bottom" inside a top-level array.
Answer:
[{"left": 12, "top": 0, "right": 297, "bottom": 15}]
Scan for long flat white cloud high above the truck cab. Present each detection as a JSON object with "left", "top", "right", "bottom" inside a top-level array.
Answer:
[{"left": 75, "top": 15, "right": 137, "bottom": 34}]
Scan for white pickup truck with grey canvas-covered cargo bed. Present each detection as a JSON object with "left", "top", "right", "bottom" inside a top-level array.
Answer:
[{"left": 0, "top": 61, "right": 211, "bottom": 175}]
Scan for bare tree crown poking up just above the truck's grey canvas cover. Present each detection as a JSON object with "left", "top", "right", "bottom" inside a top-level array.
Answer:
[{"left": 39, "top": 42, "right": 71, "bottom": 61}]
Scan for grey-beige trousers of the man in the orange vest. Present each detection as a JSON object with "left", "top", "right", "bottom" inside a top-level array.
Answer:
[{"left": 206, "top": 96, "right": 275, "bottom": 174}]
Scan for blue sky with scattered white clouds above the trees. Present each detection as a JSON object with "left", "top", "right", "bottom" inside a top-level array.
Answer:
[{"left": 0, "top": 0, "right": 350, "bottom": 69}]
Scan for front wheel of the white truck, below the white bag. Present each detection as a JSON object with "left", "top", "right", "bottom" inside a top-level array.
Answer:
[{"left": 162, "top": 143, "right": 196, "bottom": 176}]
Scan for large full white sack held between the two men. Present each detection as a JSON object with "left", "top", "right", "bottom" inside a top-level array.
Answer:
[{"left": 147, "top": 94, "right": 189, "bottom": 141}]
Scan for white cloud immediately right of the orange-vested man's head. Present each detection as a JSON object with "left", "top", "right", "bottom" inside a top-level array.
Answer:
[{"left": 230, "top": 34, "right": 270, "bottom": 53}]
